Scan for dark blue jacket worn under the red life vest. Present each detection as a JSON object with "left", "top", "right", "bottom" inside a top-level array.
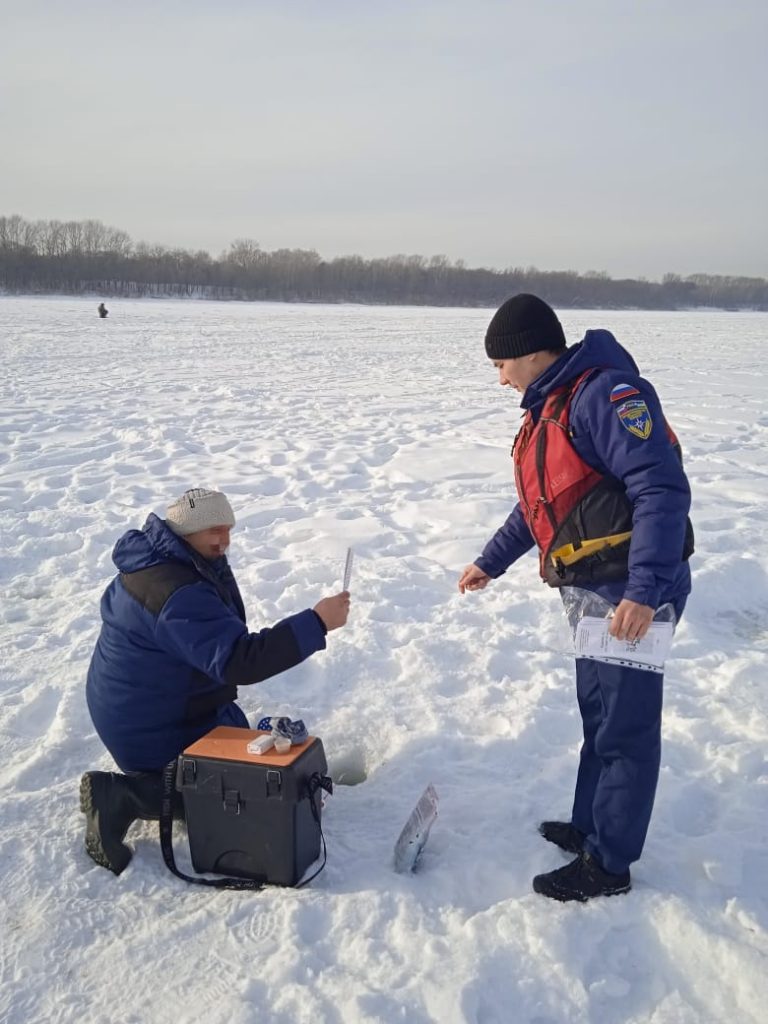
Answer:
[{"left": 475, "top": 331, "right": 690, "bottom": 610}]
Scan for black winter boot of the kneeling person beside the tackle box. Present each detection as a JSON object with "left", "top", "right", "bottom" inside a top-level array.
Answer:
[{"left": 80, "top": 771, "right": 163, "bottom": 874}]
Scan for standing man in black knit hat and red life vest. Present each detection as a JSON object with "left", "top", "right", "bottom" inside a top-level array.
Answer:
[{"left": 459, "top": 295, "right": 693, "bottom": 901}]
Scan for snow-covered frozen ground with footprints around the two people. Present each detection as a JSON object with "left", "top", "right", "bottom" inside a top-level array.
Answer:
[{"left": 0, "top": 298, "right": 768, "bottom": 1024}]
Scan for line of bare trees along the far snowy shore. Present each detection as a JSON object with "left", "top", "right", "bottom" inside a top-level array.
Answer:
[{"left": 0, "top": 214, "right": 768, "bottom": 310}]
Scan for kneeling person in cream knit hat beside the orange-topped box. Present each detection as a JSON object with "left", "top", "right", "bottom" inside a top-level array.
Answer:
[{"left": 80, "top": 488, "right": 349, "bottom": 874}]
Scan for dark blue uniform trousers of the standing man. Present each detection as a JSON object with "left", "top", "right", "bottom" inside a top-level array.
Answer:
[{"left": 571, "top": 657, "right": 664, "bottom": 874}]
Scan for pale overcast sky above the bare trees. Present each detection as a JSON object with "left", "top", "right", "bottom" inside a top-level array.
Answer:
[{"left": 0, "top": 0, "right": 768, "bottom": 279}]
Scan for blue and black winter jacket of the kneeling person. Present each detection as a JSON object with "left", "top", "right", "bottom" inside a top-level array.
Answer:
[{"left": 86, "top": 515, "right": 326, "bottom": 771}]
